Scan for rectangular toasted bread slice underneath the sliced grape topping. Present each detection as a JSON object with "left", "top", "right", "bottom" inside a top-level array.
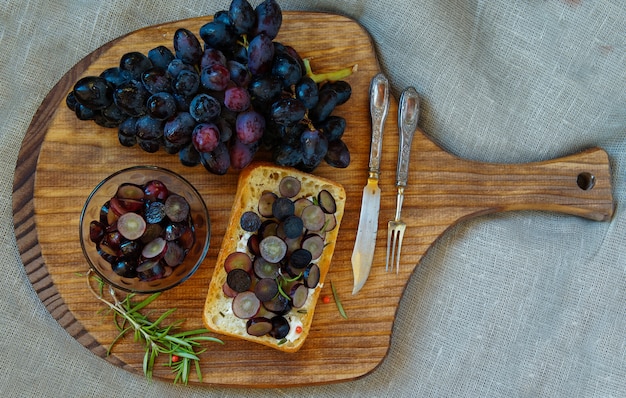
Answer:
[{"left": 202, "top": 162, "right": 346, "bottom": 352}]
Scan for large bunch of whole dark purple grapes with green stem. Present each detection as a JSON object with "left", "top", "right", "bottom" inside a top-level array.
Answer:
[{"left": 66, "top": 0, "right": 352, "bottom": 174}]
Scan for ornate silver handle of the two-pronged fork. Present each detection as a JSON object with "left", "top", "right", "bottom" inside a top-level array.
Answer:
[{"left": 396, "top": 87, "right": 420, "bottom": 187}]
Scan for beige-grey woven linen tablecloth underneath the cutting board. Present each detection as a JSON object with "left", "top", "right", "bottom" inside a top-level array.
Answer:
[{"left": 0, "top": 0, "right": 626, "bottom": 397}]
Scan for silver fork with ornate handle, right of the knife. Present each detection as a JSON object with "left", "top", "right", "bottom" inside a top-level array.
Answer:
[{"left": 385, "top": 87, "right": 419, "bottom": 273}]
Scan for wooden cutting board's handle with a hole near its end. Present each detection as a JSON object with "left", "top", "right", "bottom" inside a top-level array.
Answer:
[{"left": 410, "top": 143, "right": 615, "bottom": 221}]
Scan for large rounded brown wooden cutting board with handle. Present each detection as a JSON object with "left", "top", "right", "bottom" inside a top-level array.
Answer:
[{"left": 13, "top": 12, "right": 613, "bottom": 387}]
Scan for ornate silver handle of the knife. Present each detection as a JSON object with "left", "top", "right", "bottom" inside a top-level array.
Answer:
[{"left": 369, "top": 73, "right": 389, "bottom": 179}]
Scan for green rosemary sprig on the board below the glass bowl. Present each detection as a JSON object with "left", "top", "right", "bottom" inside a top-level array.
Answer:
[{"left": 87, "top": 273, "right": 224, "bottom": 384}]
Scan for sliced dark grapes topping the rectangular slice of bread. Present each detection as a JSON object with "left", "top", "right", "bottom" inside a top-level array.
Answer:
[{"left": 222, "top": 176, "right": 337, "bottom": 340}]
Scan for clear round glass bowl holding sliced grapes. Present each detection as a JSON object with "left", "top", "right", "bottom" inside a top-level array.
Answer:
[{"left": 80, "top": 166, "right": 211, "bottom": 294}]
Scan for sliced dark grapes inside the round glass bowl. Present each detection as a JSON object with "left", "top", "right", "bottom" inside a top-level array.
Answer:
[{"left": 89, "top": 180, "right": 195, "bottom": 281}]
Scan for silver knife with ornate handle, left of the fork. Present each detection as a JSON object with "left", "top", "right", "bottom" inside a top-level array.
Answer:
[{"left": 352, "top": 73, "right": 389, "bottom": 294}]
